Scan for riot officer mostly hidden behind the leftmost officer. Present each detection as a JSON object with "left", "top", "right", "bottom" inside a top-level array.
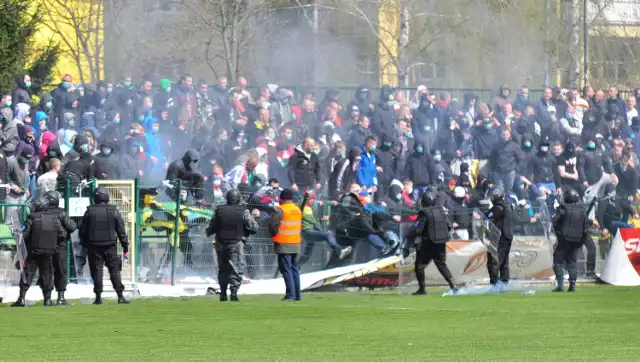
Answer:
[{"left": 44, "top": 191, "right": 75, "bottom": 305}]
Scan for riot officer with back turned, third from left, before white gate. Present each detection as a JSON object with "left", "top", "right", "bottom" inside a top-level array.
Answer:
[{"left": 80, "top": 187, "right": 129, "bottom": 304}]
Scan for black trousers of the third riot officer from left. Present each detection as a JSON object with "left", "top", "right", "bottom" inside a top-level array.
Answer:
[{"left": 89, "top": 245, "right": 124, "bottom": 293}]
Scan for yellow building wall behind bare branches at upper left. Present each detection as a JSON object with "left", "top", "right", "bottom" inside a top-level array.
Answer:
[{"left": 43, "top": 0, "right": 104, "bottom": 83}]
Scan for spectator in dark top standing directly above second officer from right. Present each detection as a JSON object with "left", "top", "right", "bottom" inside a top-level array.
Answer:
[{"left": 491, "top": 130, "right": 522, "bottom": 194}]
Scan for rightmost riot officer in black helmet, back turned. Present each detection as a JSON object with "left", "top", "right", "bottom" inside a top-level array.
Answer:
[{"left": 553, "top": 189, "right": 590, "bottom": 292}]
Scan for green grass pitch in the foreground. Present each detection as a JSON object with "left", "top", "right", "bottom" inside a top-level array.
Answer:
[{"left": 0, "top": 286, "right": 640, "bottom": 361}]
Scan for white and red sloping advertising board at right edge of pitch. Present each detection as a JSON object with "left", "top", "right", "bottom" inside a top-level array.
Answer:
[{"left": 600, "top": 229, "right": 640, "bottom": 286}]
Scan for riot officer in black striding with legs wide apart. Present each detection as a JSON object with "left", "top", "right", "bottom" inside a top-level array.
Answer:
[{"left": 403, "top": 191, "right": 457, "bottom": 295}]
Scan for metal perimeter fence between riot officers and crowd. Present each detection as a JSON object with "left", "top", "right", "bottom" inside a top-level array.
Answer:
[{"left": 0, "top": 181, "right": 609, "bottom": 287}]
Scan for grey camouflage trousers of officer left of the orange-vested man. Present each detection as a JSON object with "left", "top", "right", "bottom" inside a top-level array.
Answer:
[{"left": 216, "top": 241, "right": 245, "bottom": 294}]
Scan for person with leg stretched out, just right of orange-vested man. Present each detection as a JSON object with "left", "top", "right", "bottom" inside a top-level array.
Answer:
[{"left": 298, "top": 192, "right": 352, "bottom": 265}]
